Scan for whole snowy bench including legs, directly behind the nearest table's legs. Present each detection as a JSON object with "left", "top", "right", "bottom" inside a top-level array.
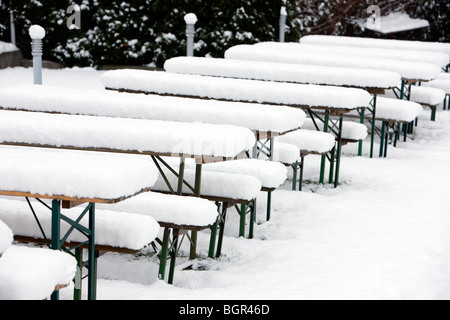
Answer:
[{"left": 0, "top": 199, "right": 159, "bottom": 300}]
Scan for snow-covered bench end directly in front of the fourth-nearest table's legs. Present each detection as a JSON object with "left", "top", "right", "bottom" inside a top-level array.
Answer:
[{"left": 276, "top": 129, "right": 336, "bottom": 191}]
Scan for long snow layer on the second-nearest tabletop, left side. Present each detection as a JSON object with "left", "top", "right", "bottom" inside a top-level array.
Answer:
[{"left": 0, "top": 111, "right": 256, "bottom": 157}]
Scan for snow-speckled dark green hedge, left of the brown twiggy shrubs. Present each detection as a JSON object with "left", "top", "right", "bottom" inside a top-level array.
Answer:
[{"left": 0, "top": 0, "right": 300, "bottom": 67}]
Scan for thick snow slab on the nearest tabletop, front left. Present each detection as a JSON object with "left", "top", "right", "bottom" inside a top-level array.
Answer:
[{"left": 0, "top": 146, "right": 158, "bottom": 200}]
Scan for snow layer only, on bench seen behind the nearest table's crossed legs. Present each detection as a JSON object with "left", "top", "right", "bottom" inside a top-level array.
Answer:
[{"left": 0, "top": 199, "right": 159, "bottom": 250}]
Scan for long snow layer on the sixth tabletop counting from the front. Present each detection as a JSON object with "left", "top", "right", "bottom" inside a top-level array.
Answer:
[{"left": 225, "top": 45, "right": 441, "bottom": 80}]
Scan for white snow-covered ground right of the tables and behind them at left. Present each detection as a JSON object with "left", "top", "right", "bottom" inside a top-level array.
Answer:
[{"left": 0, "top": 68, "right": 450, "bottom": 300}]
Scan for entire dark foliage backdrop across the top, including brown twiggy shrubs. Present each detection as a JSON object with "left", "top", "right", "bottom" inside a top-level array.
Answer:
[{"left": 0, "top": 0, "right": 450, "bottom": 67}]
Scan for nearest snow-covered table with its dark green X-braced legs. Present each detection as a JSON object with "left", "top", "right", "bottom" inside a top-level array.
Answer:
[{"left": 0, "top": 146, "right": 157, "bottom": 299}]
